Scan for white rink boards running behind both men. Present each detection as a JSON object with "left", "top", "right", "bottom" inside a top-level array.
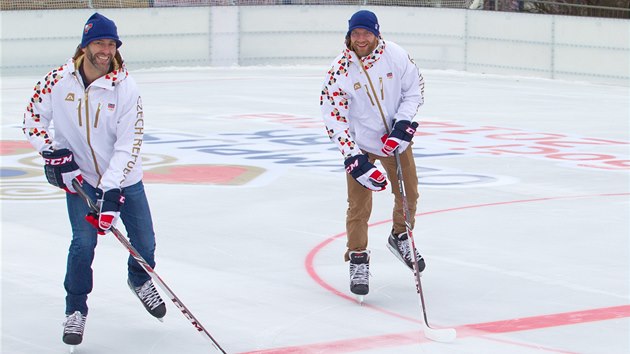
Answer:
[{"left": 0, "top": 5, "right": 630, "bottom": 85}]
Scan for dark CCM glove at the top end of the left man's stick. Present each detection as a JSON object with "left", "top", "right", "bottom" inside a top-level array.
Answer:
[{"left": 42, "top": 149, "right": 83, "bottom": 194}]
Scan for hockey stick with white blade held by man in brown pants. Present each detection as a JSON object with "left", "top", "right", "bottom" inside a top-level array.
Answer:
[{"left": 394, "top": 148, "right": 457, "bottom": 343}]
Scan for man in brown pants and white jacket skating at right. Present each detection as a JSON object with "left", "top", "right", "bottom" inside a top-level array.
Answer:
[{"left": 320, "top": 10, "right": 425, "bottom": 301}]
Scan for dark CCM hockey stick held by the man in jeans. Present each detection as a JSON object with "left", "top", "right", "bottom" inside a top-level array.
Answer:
[{"left": 72, "top": 179, "right": 225, "bottom": 354}]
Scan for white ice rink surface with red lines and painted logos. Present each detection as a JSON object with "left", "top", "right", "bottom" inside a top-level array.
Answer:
[{"left": 0, "top": 67, "right": 630, "bottom": 354}]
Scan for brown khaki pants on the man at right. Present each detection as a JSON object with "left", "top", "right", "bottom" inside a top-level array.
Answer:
[{"left": 344, "top": 146, "right": 420, "bottom": 261}]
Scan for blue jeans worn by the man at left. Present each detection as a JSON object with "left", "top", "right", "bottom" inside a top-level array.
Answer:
[{"left": 63, "top": 181, "right": 155, "bottom": 315}]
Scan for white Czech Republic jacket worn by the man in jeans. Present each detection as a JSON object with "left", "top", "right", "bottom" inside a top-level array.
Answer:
[{"left": 23, "top": 57, "right": 144, "bottom": 190}]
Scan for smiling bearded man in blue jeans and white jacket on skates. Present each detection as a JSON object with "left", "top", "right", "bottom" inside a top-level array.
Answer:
[{"left": 23, "top": 13, "right": 166, "bottom": 346}]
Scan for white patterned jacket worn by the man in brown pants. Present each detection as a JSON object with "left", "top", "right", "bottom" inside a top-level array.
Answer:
[{"left": 320, "top": 39, "right": 424, "bottom": 158}]
